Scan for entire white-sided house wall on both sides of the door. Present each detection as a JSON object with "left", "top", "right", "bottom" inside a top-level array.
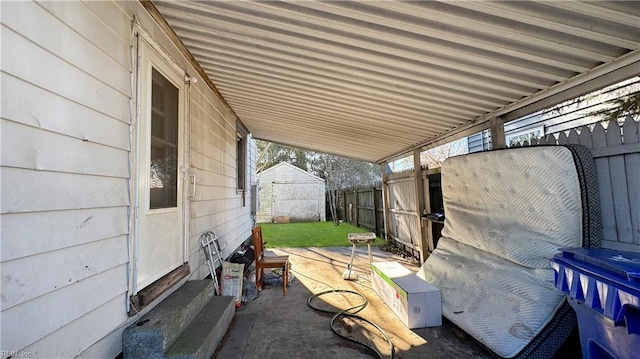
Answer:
[{"left": 0, "top": 1, "right": 256, "bottom": 358}]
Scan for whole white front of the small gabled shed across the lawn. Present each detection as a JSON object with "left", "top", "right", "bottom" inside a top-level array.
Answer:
[{"left": 256, "top": 162, "right": 326, "bottom": 223}]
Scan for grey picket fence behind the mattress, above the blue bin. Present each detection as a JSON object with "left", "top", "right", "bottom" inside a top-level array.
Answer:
[{"left": 522, "top": 116, "right": 640, "bottom": 252}]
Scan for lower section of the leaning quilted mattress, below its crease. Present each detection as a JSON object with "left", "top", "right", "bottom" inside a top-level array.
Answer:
[{"left": 418, "top": 237, "right": 564, "bottom": 358}]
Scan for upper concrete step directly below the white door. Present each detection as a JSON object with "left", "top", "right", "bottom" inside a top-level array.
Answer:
[{"left": 122, "top": 280, "right": 215, "bottom": 358}]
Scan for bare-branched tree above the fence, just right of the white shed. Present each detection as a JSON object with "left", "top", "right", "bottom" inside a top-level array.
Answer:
[{"left": 311, "top": 154, "right": 381, "bottom": 226}]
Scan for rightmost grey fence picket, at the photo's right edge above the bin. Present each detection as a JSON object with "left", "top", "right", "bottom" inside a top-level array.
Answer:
[{"left": 622, "top": 116, "right": 640, "bottom": 244}]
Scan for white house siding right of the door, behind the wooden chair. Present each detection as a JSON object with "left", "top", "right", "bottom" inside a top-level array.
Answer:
[{"left": 189, "top": 81, "right": 255, "bottom": 276}]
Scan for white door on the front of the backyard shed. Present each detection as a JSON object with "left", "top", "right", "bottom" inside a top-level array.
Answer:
[{"left": 271, "top": 182, "right": 324, "bottom": 222}]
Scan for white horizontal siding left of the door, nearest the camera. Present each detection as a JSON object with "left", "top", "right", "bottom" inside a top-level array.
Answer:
[{"left": 0, "top": 2, "right": 132, "bottom": 357}]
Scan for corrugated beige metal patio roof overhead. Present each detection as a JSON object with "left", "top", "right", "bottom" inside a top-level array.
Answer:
[{"left": 147, "top": 0, "right": 640, "bottom": 162}]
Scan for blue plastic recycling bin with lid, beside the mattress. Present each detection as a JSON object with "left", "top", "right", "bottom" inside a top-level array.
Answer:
[{"left": 551, "top": 248, "right": 640, "bottom": 359}]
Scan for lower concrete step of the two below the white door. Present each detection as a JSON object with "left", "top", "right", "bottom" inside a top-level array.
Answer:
[{"left": 165, "top": 297, "right": 236, "bottom": 359}]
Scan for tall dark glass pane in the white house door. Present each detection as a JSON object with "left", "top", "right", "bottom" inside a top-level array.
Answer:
[{"left": 149, "top": 69, "right": 179, "bottom": 209}]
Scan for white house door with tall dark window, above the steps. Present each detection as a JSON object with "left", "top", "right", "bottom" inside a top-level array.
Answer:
[{"left": 135, "top": 40, "right": 186, "bottom": 291}]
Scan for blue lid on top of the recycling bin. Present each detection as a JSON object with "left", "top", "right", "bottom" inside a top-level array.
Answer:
[{"left": 560, "top": 248, "right": 640, "bottom": 282}]
